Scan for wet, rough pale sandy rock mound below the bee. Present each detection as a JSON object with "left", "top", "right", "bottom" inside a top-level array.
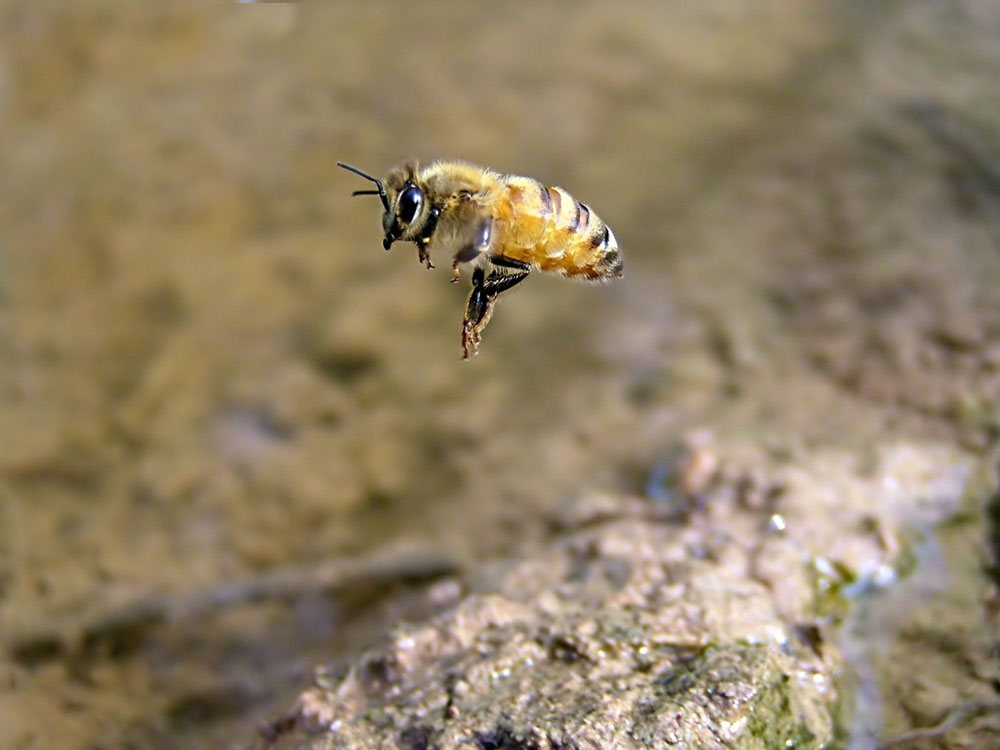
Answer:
[{"left": 272, "top": 445, "right": 968, "bottom": 750}]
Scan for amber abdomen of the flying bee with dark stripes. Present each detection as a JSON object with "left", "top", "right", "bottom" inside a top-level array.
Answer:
[{"left": 497, "top": 177, "right": 622, "bottom": 280}]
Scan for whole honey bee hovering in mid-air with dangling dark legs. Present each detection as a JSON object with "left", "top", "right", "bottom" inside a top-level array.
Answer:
[{"left": 337, "top": 161, "right": 622, "bottom": 359}]
